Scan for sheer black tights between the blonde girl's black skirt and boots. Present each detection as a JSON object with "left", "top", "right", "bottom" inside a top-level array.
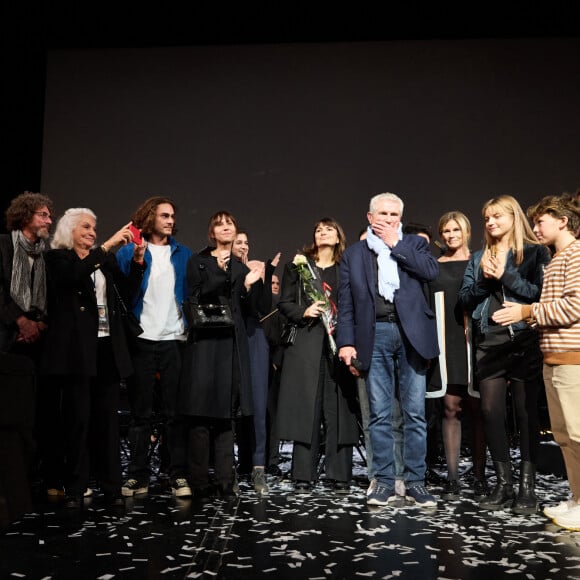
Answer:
[{"left": 479, "top": 378, "right": 541, "bottom": 463}]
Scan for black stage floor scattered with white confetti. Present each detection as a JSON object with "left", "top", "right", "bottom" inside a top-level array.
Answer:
[{"left": 0, "top": 448, "right": 580, "bottom": 580}]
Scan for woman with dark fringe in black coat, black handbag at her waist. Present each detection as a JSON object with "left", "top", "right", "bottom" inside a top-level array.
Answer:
[{"left": 179, "top": 211, "right": 264, "bottom": 498}]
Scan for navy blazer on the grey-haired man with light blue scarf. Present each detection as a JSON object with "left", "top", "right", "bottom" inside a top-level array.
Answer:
[{"left": 336, "top": 234, "right": 439, "bottom": 370}]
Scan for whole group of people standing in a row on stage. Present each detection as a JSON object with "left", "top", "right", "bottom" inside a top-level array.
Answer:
[{"left": 0, "top": 192, "right": 580, "bottom": 529}]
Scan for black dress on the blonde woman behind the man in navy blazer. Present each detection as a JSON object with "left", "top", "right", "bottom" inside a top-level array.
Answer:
[{"left": 429, "top": 260, "right": 469, "bottom": 391}]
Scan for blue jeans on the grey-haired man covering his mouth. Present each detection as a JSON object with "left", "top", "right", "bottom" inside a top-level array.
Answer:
[{"left": 367, "top": 322, "right": 427, "bottom": 487}]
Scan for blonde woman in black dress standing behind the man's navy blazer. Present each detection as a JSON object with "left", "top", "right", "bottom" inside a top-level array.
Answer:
[{"left": 430, "top": 211, "right": 487, "bottom": 500}]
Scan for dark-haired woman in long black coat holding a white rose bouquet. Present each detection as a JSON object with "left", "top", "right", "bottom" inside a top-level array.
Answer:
[{"left": 278, "top": 218, "right": 358, "bottom": 493}]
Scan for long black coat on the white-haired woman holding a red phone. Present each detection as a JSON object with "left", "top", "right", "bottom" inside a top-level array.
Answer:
[{"left": 41, "top": 248, "right": 140, "bottom": 377}]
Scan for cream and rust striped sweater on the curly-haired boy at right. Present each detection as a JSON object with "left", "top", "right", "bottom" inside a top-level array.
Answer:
[{"left": 531, "top": 240, "right": 580, "bottom": 365}]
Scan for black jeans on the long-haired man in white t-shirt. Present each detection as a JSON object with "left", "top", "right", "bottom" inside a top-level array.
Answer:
[{"left": 128, "top": 338, "right": 187, "bottom": 482}]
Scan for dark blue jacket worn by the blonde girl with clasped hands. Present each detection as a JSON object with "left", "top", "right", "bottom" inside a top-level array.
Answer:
[{"left": 459, "top": 244, "right": 550, "bottom": 333}]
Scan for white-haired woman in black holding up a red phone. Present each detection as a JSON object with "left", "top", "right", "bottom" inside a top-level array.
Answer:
[{"left": 42, "top": 208, "right": 144, "bottom": 507}]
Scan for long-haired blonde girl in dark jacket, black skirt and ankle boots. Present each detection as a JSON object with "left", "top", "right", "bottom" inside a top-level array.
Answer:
[{"left": 460, "top": 195, "right": 550, "bottom": 514}]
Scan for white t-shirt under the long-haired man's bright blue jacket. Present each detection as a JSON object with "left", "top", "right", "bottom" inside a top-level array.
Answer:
[{"left": 139, "top": 244, "right": 186, "bottom": 340}]
